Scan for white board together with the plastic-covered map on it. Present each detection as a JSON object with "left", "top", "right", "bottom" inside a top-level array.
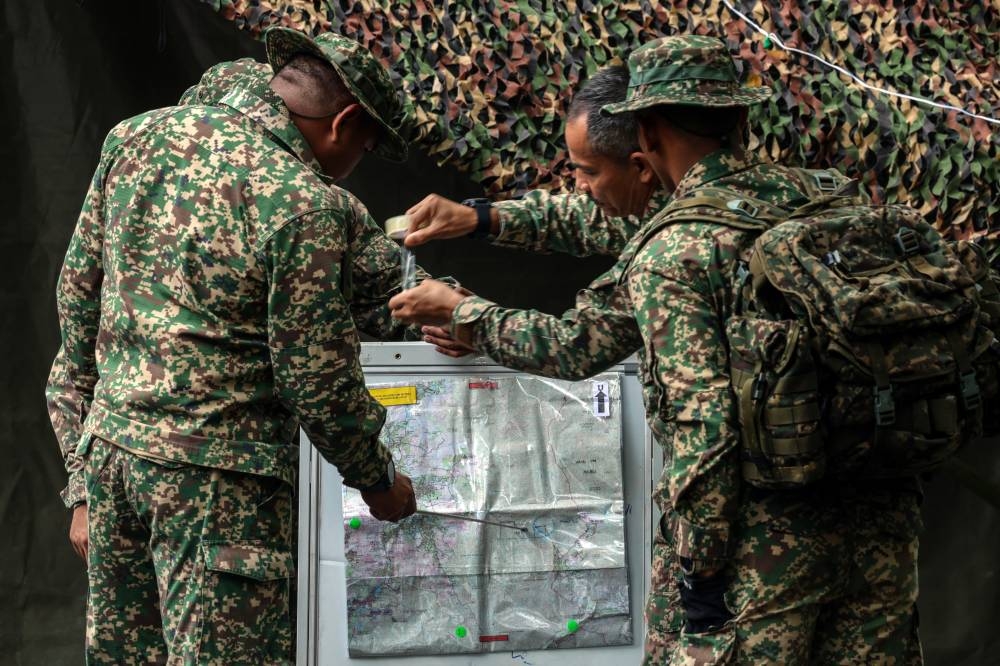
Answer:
[{"left": 298, "top": 343, "right": 658, "bottom": 666}]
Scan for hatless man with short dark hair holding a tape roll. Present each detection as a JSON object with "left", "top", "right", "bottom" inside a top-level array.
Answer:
[{"left": 386, "top": 65, "right": 683, "bottom": 663}]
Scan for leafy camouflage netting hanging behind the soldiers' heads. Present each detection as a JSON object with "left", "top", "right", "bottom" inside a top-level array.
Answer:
[{"left": 201, "top": 0, "right": 1000, "bottom": 244}]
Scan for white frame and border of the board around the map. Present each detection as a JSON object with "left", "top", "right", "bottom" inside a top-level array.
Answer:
[{"left": 297, "top": 342, "right": 661, "bottom": 666}]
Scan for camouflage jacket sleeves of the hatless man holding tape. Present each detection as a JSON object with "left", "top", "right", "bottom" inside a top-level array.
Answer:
[{"left": 452, "top": 190, "right": 670, "bottom": 379}]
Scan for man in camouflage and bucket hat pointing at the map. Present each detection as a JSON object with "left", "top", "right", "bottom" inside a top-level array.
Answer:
[{"left": 47, "top": 29, "right": 415, "bottom": 664}]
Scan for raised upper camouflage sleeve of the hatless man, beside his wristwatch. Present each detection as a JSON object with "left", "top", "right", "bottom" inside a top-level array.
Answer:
[{"left": 493, "top": 190, "right": 669, "bottom": 257}]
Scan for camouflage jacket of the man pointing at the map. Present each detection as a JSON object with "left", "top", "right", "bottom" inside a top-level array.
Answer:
[{"left": 47, "top": 79, "right": 399, "bottom": 505}]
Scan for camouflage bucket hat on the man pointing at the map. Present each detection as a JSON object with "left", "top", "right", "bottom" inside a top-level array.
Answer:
[{"left": 264, "top": 27, "right": 407, "bottom": 162}]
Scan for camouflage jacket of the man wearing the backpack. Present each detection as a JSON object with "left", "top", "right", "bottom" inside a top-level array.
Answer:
[{"left": 625, "top": 150, "right": 832, "bottom": 570}]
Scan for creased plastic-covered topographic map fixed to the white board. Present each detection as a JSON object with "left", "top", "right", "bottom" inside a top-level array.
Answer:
[{"left": 343, "top": 373, "right": 632, "bottom": 656}]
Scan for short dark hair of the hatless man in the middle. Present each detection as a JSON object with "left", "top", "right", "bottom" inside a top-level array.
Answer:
[{"left": 566, "top": 65, "right": 639, "bottom": 161}]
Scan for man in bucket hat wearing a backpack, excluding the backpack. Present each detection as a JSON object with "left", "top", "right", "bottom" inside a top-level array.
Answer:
[{"left": 605, "top": 36, "right": 921, "bottom": 664}]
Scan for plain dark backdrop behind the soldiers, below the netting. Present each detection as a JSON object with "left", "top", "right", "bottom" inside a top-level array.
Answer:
[{"left": 0, "top": 0, "right": 1000, "bottom": 665}]
